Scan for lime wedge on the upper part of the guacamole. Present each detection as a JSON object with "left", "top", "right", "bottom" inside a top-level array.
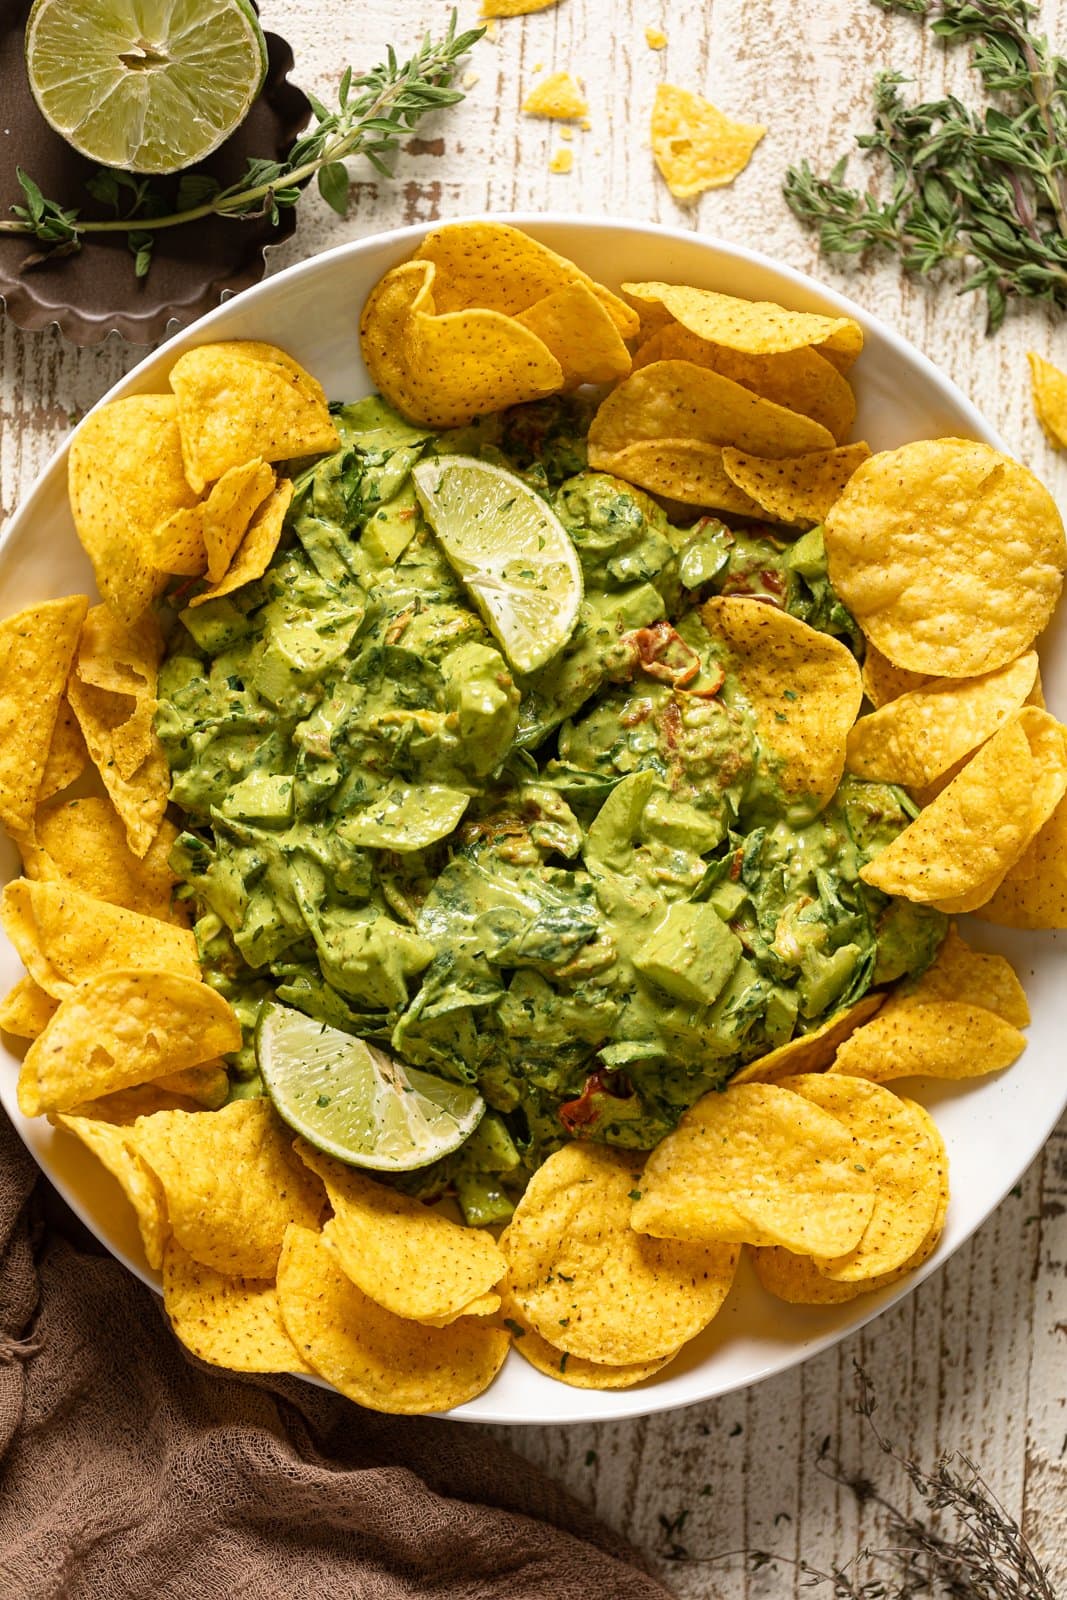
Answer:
[{"left": 411, "top": 456, "right": 582, "bottom": 672}]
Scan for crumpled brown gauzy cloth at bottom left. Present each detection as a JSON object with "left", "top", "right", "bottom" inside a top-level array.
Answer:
[{"left": 0, "top": 1114, "right": 667, "bottom": 1600}]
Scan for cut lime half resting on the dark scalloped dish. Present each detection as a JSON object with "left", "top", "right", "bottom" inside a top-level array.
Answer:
[{"left": 26, "top": 0, "right": 267, "bottom": 173}]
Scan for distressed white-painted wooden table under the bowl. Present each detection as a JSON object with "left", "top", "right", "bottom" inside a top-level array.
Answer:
[{"left": 0, "top": 0, "right": 1067, "bottom": 1600}]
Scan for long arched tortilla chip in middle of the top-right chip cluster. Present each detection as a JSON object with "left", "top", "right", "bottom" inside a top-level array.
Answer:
[{"left": 589, "top": 362, "right": 833, "bottom": 467}]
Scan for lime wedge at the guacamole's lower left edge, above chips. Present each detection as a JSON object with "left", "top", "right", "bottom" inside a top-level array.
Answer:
[{"left": 256, "top": 1000, "right": 485, "bottom": 1173}]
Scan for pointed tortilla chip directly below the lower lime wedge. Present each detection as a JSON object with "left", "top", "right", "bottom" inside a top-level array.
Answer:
[{"left": 296, "top": 1139, "right": 507, "bottom": 1323}]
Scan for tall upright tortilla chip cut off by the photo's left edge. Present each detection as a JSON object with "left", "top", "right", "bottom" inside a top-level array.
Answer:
[{"left": 0, "top": 595, "right": 88, "bottom": 834}]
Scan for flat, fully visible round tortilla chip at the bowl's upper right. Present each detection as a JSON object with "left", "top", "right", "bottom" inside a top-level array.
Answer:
[{"left": 825, "top": 438, "right": 1067, "bottom": 678}]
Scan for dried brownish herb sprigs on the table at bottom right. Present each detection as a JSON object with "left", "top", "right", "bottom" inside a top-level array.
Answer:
[{"left": 661, "top": 1365, "right": 1056, "bottom": 1600}]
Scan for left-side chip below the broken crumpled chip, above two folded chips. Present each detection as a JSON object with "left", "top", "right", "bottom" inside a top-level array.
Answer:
[{"left": 27, "top": 795, "right": 189, "bottom": 928}]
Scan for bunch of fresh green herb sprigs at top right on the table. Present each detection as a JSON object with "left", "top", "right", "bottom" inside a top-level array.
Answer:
[{"left": 784, "top": 0, "right": 1067, "bottom": 333}]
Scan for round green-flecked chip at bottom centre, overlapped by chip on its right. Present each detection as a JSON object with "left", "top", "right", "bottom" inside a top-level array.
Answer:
[{"left": 501, "top": 1142, "right": 737, "bottom": 1366}]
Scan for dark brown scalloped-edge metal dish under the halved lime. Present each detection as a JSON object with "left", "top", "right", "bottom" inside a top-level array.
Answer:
[{"left": 0, "top": 0, "right": 310, "bottom": 346}]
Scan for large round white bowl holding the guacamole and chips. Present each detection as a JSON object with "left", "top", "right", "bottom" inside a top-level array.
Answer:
[{"left": 0, "top": 216, "right": 1067, "bottom": 1422}]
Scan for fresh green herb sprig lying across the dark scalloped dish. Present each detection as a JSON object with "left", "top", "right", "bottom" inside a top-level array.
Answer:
[{"left": 0, "top": 11, "right": 485, "bottom": 277}]
